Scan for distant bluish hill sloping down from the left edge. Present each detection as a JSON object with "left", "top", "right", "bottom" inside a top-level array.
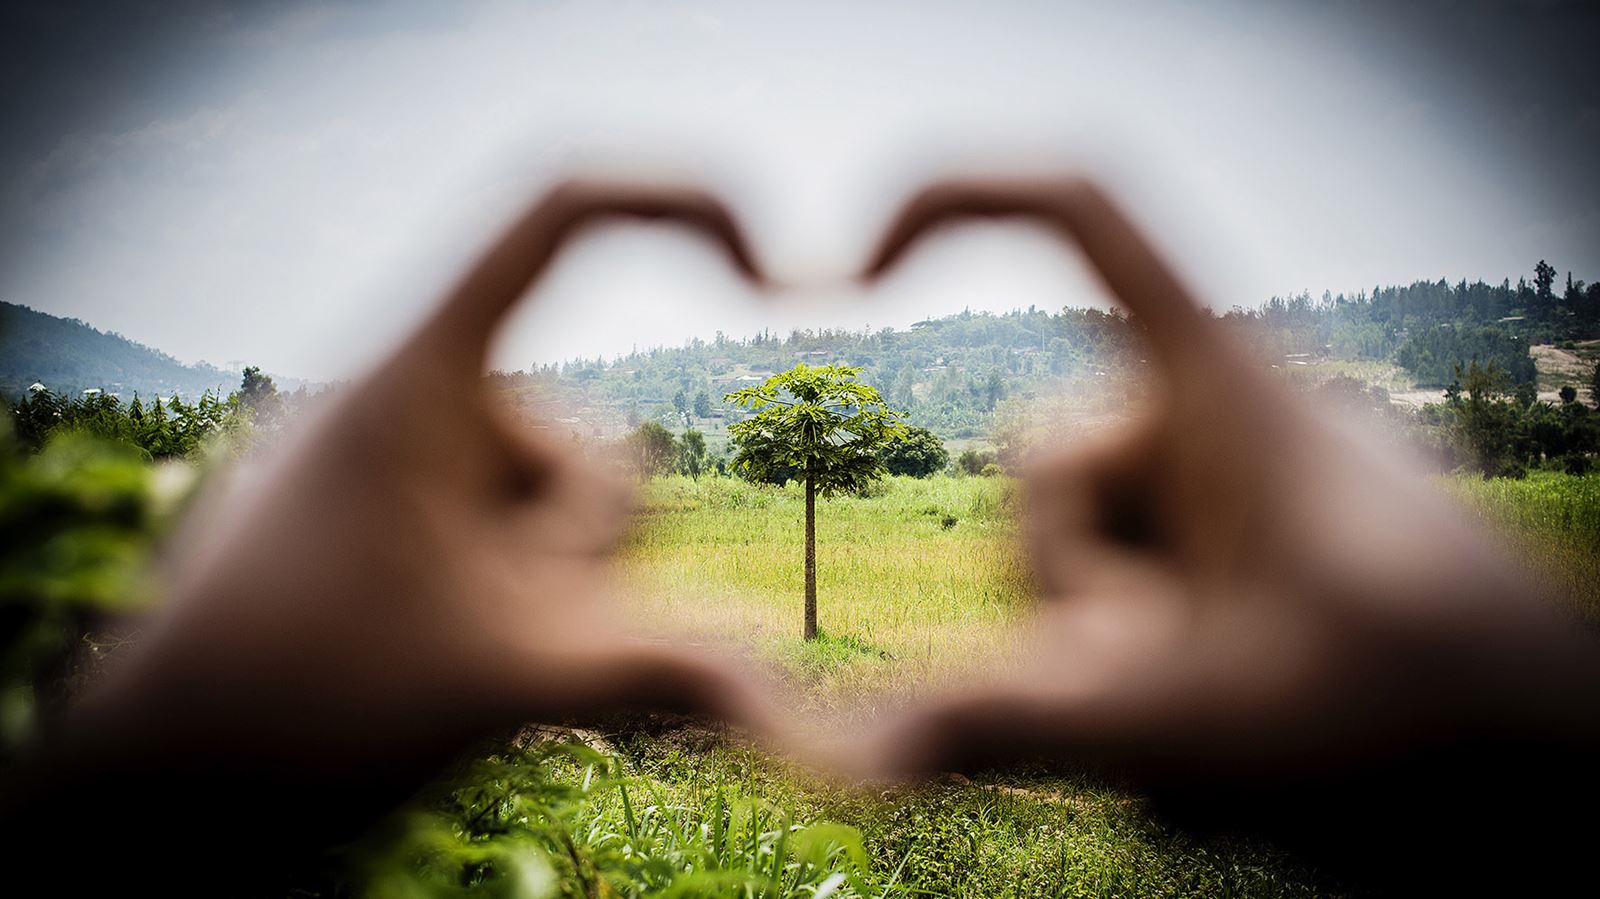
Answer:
[{"left": 0, "top": 302, "right": 240, "bottom": 397}]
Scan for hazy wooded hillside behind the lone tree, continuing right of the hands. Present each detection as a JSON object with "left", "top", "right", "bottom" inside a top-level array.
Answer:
[{"left": 496, "top": 268, "right": 1600, "bottom": 450}]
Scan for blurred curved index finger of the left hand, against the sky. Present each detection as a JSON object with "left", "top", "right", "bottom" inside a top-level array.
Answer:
[{"left": 421, "top": 181, "right": 765, "bottom": 378}]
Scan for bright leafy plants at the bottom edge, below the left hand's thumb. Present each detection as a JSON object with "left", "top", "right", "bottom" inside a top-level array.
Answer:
[{"left": 354, "top": 739, "right": 907, "bottom": 899}]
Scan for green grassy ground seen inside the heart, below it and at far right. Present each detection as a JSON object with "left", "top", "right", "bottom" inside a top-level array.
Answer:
[{"left": 360, "top": 473, "right": 1600, "bottom": 897}]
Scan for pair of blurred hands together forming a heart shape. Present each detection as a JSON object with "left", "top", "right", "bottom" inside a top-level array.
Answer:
[{"left": 56, "top": 178, "right": 1594, "bottom": 889}]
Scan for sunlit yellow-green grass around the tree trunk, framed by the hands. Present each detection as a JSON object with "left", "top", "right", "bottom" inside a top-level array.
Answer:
[{"left": 619, "top": 477, "right": 1032, "bottom": 710}]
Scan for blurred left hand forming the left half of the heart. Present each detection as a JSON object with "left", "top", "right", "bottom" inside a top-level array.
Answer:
[{"left": 1, "top": 182, "right": 765, "bottom": 883}]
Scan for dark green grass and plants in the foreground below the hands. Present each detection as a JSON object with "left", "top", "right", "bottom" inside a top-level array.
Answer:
[{"left": 363, "top": 728, "right": 1317, "bottom": 899}]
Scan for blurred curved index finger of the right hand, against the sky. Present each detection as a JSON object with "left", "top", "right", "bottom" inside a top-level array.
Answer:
[{"left": 862, "top": 178, "right": 1235, "bottom": 381}]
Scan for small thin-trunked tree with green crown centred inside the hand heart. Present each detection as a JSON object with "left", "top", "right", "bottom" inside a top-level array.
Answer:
[{"left": 726, "top": 363, "right": 906, "bottom": 640}]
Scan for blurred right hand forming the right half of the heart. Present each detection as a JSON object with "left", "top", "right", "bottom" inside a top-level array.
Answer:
[{"left": 861, "top": 179, "right": 1600, "bottom": 870}]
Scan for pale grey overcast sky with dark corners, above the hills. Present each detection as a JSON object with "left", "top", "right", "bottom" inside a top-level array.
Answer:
[{"left": 0, "top": 0, "right": 1600, "bottom": 379}]
